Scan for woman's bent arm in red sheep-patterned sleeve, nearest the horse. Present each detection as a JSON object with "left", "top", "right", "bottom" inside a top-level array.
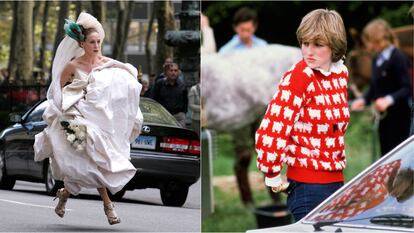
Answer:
[{"left": 255, "top": 65, "right": 311, "bottom": 187}]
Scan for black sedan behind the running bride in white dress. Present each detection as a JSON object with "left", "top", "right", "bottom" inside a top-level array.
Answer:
[{"left": 0, "top": 98, "right": 200, "bottom": 206}]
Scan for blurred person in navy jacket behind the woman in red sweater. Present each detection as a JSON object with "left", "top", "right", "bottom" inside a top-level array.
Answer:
[{"left": 351, "top": 19, "right": 412, "bottom": 156}]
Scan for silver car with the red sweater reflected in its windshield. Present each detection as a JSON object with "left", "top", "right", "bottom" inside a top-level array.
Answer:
[{"left": 248, "top": 136, "right": 414, "bottom": 232}]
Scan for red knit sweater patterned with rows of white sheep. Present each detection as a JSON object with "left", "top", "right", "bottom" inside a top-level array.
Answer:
[{"left": 256, "top": 60, "right": 349, "bottom": 186}]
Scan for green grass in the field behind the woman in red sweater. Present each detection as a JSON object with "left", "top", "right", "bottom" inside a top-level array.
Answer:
[{"left": 202, "top": 110, "right": 379, "bottom": 232}]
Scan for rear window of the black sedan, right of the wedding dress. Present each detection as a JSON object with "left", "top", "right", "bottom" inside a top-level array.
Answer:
[{"left": 139, "top": 98, "right": 178, "bottom": 126}]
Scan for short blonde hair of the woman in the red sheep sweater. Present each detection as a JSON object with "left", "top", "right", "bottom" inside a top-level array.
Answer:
[{"left": 296, "top": 9, "right": 347, "bottom": 62}]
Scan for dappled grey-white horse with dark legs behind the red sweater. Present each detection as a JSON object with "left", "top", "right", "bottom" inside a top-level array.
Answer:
[{"left": 201, "top": 44, "right": 302, "bottom": 206}]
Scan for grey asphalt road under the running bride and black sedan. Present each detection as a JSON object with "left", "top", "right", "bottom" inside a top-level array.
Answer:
[{"left": 0, "top": 181, "right": 201, "bottom": 232}]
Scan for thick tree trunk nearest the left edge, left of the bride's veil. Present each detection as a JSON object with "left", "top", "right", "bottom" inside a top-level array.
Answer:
[{"left": 9, "top": 1, "right": 33, "bottom": 83}]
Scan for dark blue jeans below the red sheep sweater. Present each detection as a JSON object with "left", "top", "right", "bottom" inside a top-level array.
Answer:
[{"left": 287, "top": 179, "right": 343, "bottom": 222}]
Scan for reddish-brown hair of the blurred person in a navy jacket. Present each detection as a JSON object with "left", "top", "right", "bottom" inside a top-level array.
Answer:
[{"left": 362, "top": 19, "right": 398, "bottom": 45}]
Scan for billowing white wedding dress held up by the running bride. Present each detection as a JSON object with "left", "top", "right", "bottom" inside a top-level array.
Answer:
[{"left": 34, "top": 60, "right": 143, "bottom": 195}]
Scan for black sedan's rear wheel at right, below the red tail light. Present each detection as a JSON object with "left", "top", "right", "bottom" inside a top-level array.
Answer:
[{"left": 160, "top": 182, "right": 188, "bottom": 207}]
